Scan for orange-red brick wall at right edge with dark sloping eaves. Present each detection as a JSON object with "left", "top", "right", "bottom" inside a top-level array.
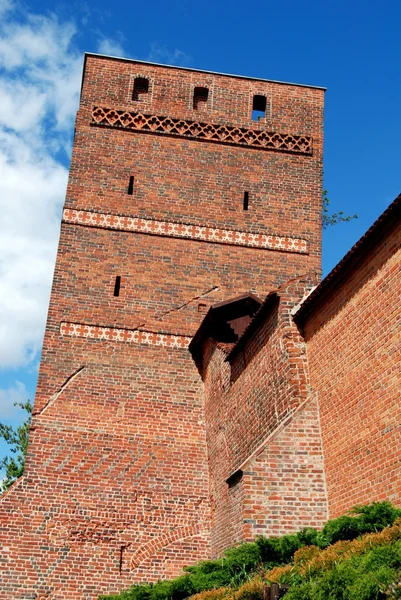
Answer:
[{"left": 305, "top": 220, "right": 401, "bottom": 517}]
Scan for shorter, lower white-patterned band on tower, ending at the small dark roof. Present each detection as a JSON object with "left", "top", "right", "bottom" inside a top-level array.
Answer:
[{"left": 60, "top": 322, "right": 192, "bottom": 348}]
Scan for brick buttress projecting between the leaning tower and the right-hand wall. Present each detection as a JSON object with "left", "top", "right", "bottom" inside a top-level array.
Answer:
[{"left": 204, "top": 280, "right": 327, "bottom": 554}]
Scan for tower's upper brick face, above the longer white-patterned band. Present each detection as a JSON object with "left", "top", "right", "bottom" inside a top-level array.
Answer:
[{"left": 66, "top": 57, "right": 324, "bottom": 268}]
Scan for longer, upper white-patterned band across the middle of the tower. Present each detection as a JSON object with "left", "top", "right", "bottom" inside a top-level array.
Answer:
[{"left": 63, "top": 208, "right": 308, "bottom": 254}]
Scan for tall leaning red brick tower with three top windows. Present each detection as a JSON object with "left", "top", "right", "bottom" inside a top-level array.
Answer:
[{"left": 0, "top": 54, "right": 324, "bottom": 600}]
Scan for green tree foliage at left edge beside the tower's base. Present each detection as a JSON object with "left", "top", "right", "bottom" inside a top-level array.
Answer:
[{"left": 0, "top": 400, "right": 32, "bottom": 492}]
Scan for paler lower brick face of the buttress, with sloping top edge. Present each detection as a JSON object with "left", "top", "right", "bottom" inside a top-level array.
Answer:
[{"left": 243, "top": 396, "right": 328, "bottom": 540}]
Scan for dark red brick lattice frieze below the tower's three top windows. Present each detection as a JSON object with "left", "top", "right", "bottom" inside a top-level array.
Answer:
[{"left": 92, "top": 106, "right": 312, "bottom": 154}]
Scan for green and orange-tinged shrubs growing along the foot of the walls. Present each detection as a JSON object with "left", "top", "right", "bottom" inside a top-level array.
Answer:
[{"left": 101, "top": 502, "right": 401, "bottom": 600}]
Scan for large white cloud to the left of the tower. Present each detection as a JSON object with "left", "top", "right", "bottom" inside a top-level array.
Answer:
[{"left": 0, "top": 7, "right": 82, "bottom": 368}]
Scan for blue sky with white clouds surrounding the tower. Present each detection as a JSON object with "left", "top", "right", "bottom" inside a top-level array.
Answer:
[{"left": 0, "top": 0, "right": 401, "bottom": 466}]
